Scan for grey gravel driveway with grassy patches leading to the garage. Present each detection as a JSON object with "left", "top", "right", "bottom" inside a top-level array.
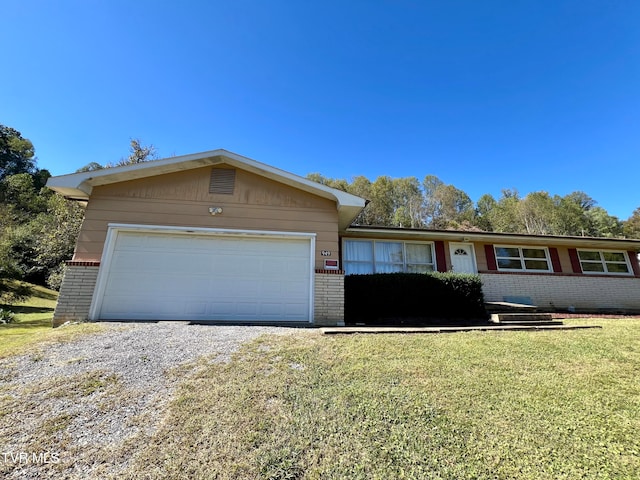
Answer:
[{"left": 0, "top": 322, "right": 300, "bottom": 479}]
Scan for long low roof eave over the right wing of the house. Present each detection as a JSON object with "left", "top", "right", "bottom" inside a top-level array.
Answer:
[{"left": 344, "top": 225, "right": 640, "bottom": 251}]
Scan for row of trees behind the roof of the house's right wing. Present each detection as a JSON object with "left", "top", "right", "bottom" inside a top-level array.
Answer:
[{"left": 307, "top": 173, "right": 640, "bottom": 238}]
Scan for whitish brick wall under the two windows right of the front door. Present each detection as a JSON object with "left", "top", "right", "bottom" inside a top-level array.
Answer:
[{"left": 480, "top": 273, "right": 640, "bottom": 313}]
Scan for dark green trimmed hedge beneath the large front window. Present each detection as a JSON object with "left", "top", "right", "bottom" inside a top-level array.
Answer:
[{"left": 344, "top": 272, "right": 487, "bottom": 325}]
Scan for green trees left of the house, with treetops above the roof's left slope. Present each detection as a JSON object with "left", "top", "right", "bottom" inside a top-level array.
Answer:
[{"left": 0, "top": 125, "right": 156, "bottom": 304}]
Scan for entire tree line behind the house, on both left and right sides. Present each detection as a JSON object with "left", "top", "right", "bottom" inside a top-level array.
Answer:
[{"left": 0, "top": 124, "right": 640, "bottom": 303}]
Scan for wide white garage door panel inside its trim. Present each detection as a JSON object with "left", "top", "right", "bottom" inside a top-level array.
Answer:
[{"left": 98, "top": 231, "right": 311, "bottom": 322}]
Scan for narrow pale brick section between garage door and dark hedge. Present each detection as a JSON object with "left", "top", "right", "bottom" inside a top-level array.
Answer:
[{"left": 313, "top": 270, "right": 344, "bottom": 325}]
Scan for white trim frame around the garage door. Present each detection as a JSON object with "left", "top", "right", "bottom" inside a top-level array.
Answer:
[{"left": 89, "top": 223, "right": 316, "bottom": 323}]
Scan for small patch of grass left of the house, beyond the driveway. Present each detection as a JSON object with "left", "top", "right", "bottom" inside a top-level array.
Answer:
[{"left": 0, "top": 285, "right": 101, "bottom": 358}]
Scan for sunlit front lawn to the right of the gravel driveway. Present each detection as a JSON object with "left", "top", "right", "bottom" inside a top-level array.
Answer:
[{"left": 125, "top": 320, "right": 640, "bottom": 480}]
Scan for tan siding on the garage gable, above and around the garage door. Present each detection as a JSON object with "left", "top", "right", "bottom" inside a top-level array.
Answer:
[{"left": 74, "top": 167, "right": 338, "bottom": 268}]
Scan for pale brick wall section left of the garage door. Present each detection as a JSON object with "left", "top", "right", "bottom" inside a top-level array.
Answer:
[{"left": 53, "top": 262, "right": 99, "bottom": 327}]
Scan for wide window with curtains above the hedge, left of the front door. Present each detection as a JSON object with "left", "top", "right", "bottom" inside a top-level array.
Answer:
[{"left": 343, "top": 240, "right": 435, "bottom": 275}]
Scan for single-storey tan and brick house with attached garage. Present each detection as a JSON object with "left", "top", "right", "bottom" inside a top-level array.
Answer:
[{"left": 47, "top": 150, "right": 640, "bottom": 326}]
